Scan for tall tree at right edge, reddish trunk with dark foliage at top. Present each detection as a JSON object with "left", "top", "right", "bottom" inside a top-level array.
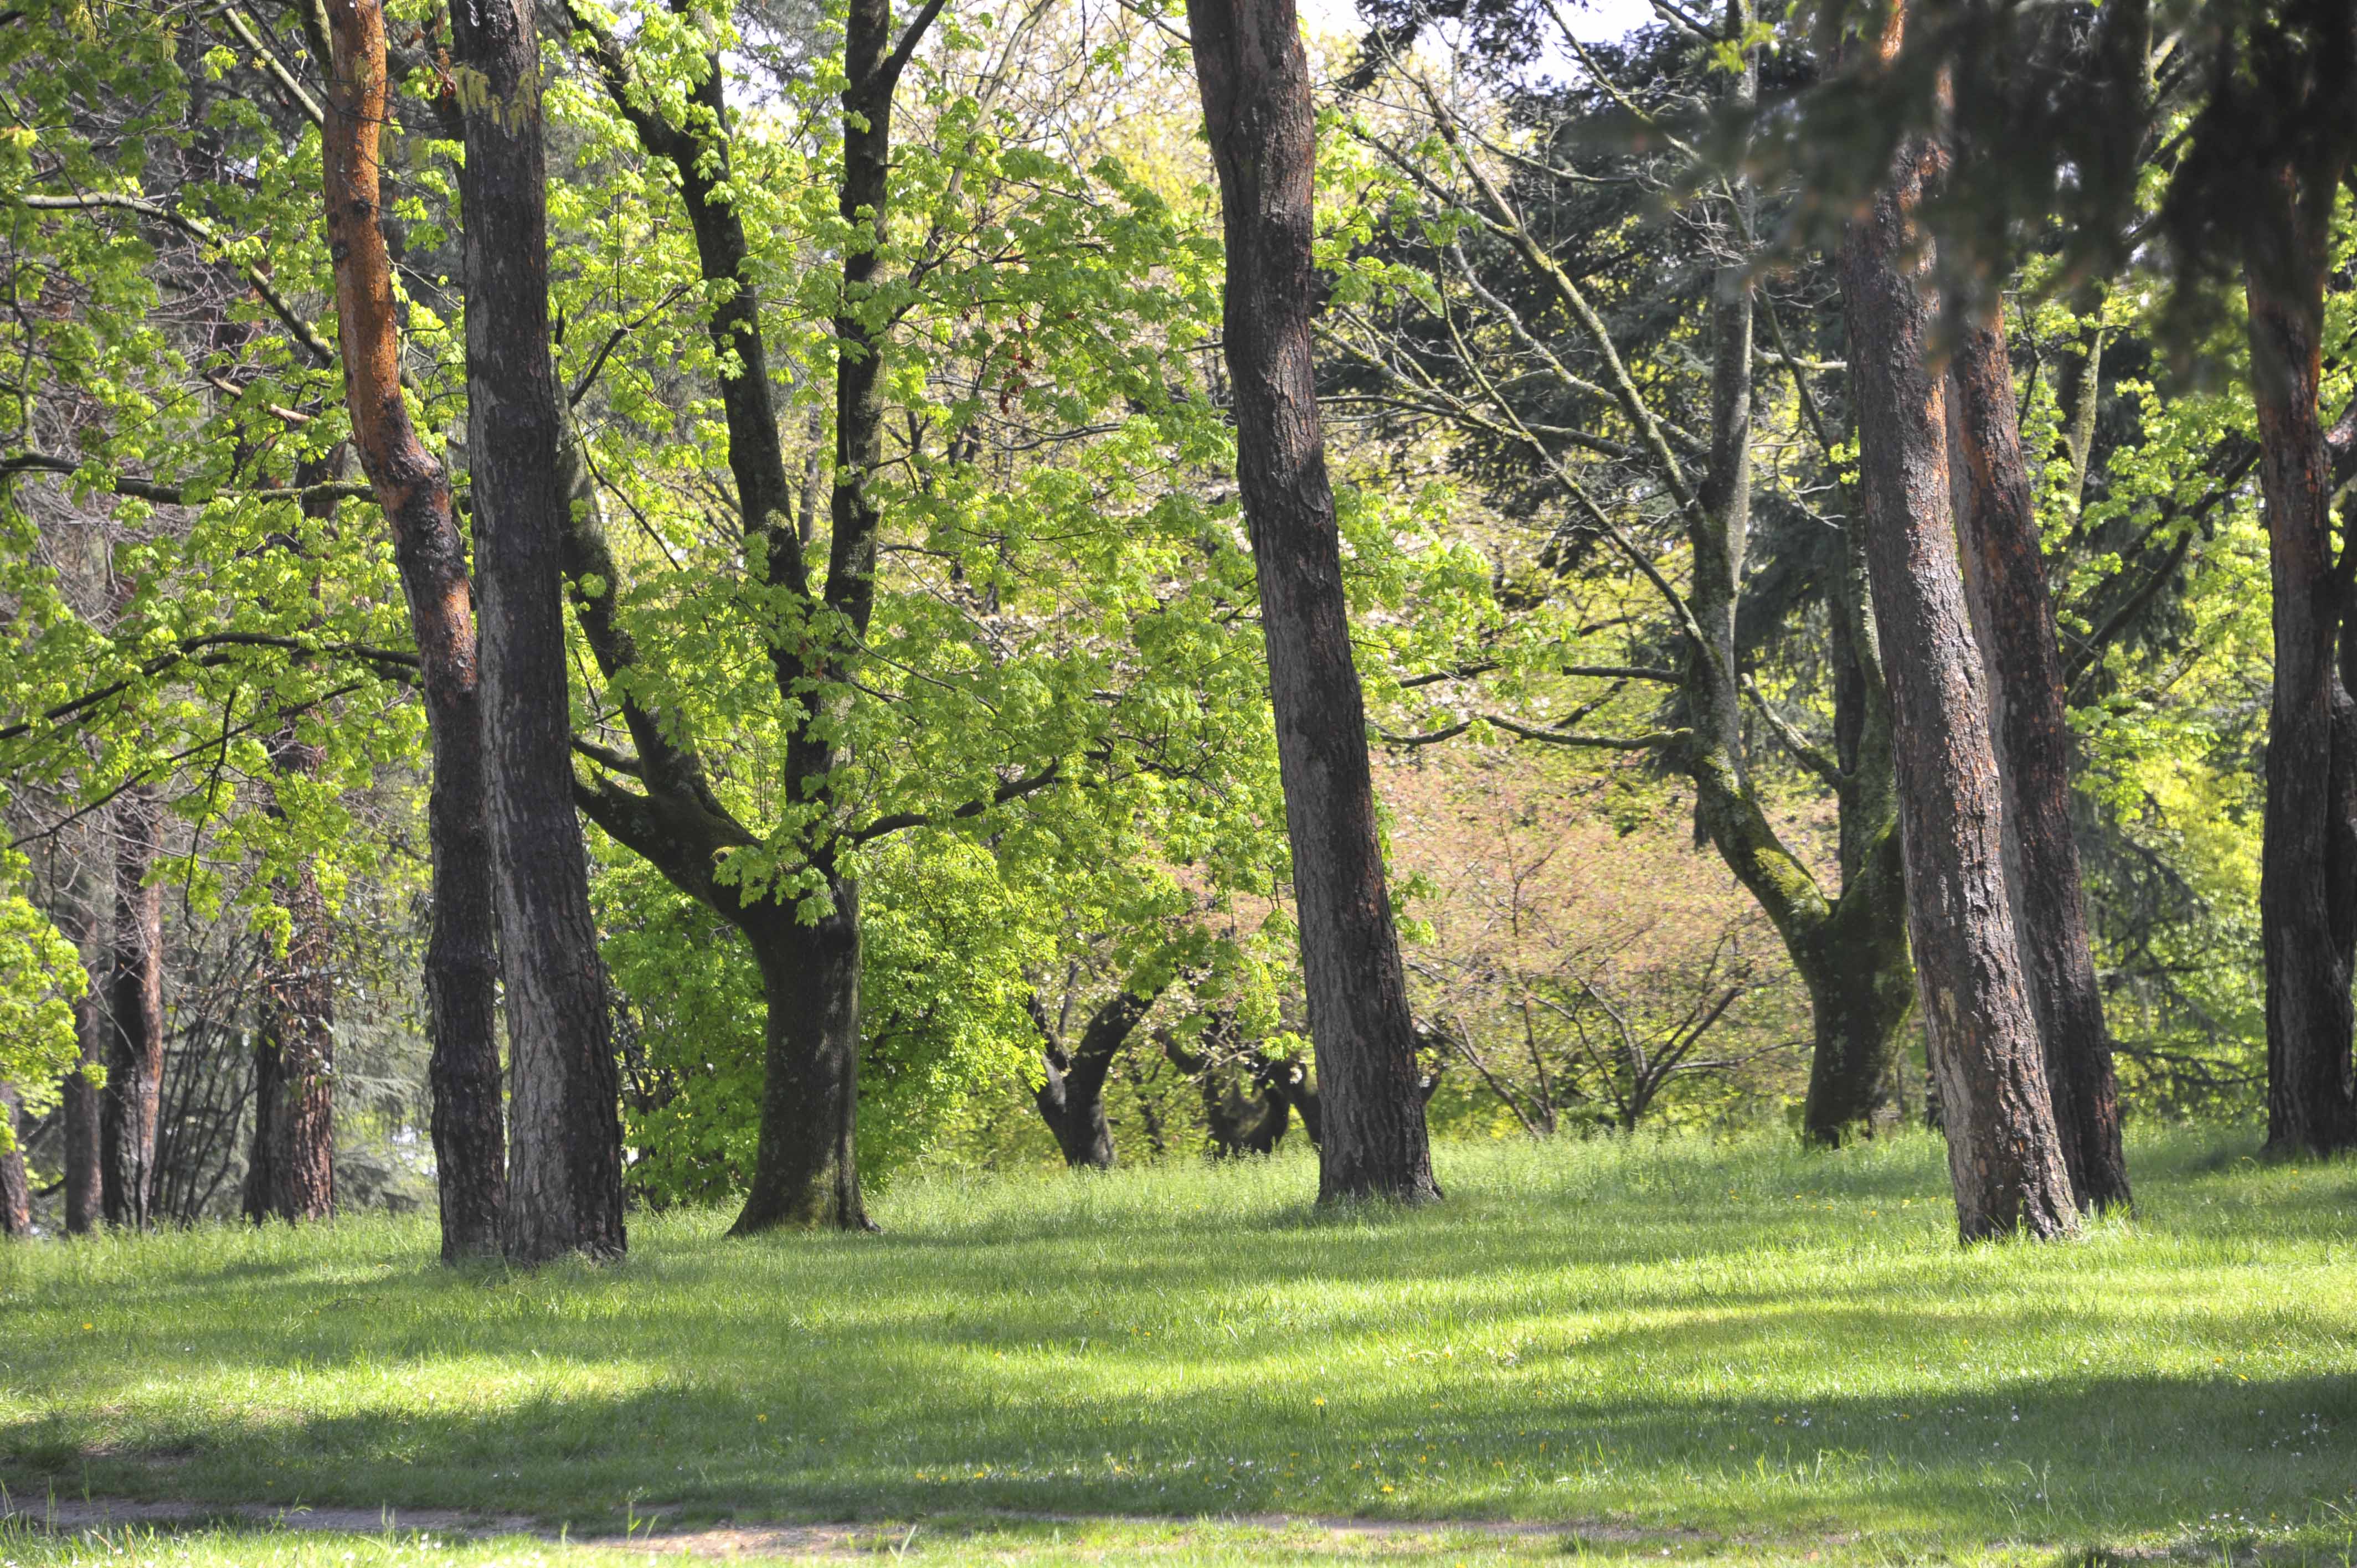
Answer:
[{"left": 2164, "top": 0, "right": 2357, "bottom": 1153}]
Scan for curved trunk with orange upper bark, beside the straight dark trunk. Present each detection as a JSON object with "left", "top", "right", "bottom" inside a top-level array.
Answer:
[{"left": 321, "top": 0, "right": 507, "bottom": 1261}]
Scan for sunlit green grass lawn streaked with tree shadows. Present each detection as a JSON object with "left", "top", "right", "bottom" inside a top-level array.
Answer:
[{"left": 0, "top": 1132, "right": 2357, "bottom": 1568}]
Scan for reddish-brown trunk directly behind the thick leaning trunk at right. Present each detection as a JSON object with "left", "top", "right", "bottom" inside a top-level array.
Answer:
[{"left": 1947, "top": 321, "right": 2128, "bottom": 1210}]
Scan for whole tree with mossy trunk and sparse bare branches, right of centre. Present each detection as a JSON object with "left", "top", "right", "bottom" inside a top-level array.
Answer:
[{"left": 1327, "top": 5, "right": 1914, "bottom": 1143}]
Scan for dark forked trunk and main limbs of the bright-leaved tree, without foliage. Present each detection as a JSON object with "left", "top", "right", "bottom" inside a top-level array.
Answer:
[{"left": 565, "top": 0, "right": 952, "bottom": 1236}]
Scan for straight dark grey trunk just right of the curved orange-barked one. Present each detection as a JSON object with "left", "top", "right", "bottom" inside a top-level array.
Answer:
[{"left": 450, "top": 0, "right": 625, "bottom": 1264}]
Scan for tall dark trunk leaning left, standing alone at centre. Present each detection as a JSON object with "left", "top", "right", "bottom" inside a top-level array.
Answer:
[{"left": 1188, "top": 0, "right": 1440, "bottom": 1203}]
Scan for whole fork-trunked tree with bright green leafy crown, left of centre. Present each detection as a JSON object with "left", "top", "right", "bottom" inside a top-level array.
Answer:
[{"left": 561, "top": 9, "right": 1265, "bottom": 1233}]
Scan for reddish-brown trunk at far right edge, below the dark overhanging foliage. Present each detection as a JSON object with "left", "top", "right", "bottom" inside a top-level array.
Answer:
[{"left": 2244, "top": 167, "right": 2357, "bottom": 1153}]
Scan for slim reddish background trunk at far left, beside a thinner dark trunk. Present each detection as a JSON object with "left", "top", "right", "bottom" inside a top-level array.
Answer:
[{"left": 99, "top": 785, "right": 163, "bottom": 1231}]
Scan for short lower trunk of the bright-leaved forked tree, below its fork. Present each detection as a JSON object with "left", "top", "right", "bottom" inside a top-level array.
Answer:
[{"left": 730, "top": 900, "right": 874, "bottom": 1236}]
